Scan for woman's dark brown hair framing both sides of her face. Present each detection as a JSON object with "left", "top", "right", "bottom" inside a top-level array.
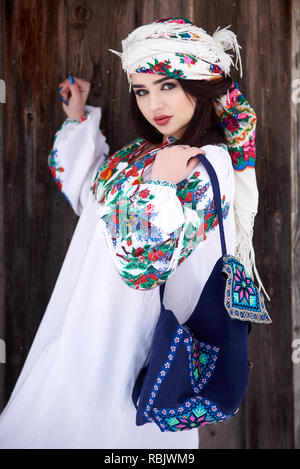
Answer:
[{"left": 130, "top": 77, "right": 232, "bottom": 147}]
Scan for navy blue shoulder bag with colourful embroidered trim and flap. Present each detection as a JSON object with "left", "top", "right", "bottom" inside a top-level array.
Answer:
[{"left": 132, "top": 154, "right": 272, "bottom": 432}]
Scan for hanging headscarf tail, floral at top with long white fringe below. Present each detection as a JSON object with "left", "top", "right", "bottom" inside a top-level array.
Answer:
[{"left": 214, "top": 81, "right": 270, "bottom": 300}]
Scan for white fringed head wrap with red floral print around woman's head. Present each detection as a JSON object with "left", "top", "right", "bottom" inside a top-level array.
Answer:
[{"left": 109, "top": 18, "right": 242, "bottom": 91}]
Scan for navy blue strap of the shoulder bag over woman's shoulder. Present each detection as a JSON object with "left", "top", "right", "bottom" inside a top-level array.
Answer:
[{"left": 159, "top": 153, "right": 227, "bottom": 306}]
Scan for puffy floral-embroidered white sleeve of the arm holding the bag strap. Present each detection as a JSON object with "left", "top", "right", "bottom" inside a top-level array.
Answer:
[{"left": 100, "top": 145, "right": 234, "bottom": 290}]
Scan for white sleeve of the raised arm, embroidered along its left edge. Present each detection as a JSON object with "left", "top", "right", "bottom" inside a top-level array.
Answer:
[{"left": 48, "top": 105, "right": 109, "bottom": 216}]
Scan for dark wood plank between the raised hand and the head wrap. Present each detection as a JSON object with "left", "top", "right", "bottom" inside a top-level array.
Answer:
[{"left": 64, "top": 0, "right": 136, "bottom": 152}]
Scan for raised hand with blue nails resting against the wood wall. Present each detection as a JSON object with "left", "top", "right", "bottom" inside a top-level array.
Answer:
[{"left": 58, "top": 76, "right": 91, "bottom": 119}]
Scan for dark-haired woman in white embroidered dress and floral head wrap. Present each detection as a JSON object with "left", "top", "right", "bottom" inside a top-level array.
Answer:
[{"left": 0, "top": 18, "right": 264, "bottom": 449}]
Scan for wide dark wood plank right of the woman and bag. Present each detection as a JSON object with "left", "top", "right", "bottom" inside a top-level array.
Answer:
[{"left": 238, "top": 0, "right": 293, "bottom": 448}]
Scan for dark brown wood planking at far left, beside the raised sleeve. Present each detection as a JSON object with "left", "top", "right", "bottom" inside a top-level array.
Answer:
[{"left": 1, "top": 1, "right": 67, "bottom": 399}]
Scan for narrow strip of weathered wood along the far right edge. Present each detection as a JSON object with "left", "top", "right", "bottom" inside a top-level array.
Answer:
[{"left": 291, "top": 0, "right": 300, "bottom": 448}]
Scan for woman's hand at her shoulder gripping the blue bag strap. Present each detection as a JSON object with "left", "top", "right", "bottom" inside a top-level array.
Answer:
[{"left": 151, "top": 145, "right": 205, "bottom": 184}]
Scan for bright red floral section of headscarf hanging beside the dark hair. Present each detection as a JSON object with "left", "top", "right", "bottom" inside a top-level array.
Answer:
[{"left": 214, "top": 81, "right": 257, "bottom": 171}]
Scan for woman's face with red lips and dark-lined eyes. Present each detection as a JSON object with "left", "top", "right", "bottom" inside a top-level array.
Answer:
[{"left": 131, "top": 73, "right": 196, "bottom": 142}]
